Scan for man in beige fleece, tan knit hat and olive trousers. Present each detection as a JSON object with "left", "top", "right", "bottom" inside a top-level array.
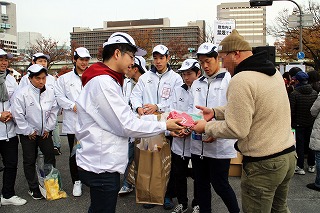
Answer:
[{"left": 194, "top": 30, "right": 296, "bottom": 212}]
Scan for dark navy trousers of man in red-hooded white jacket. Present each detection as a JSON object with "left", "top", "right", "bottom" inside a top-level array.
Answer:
[{"left": 79, "top": 169, "right": 120, "bottom": 213}]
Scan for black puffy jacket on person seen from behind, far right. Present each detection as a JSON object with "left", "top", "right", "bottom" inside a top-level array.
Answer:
[{"left": 289, "top": 84, "right": 318, "bottom": 128}]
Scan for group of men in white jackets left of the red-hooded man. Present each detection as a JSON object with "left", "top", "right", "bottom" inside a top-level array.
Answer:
[{"left": 0, "top": 47, "right": 91, "bottom": 205}]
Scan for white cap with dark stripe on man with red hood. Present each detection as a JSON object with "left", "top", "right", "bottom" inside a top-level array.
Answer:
[{"left": 102, "top": 32, "right": 147, "bottom": 56}]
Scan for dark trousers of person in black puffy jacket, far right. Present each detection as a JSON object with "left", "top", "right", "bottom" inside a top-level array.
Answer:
[{"left": 296, "top": 127, "right": 315, "bottom": 169}]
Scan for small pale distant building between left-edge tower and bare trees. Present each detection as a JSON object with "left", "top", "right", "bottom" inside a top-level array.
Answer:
[{"left": 18, "top": 32, "right": 42, "bottom": 53}]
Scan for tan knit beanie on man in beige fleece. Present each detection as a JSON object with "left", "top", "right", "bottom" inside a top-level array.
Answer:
[{"left": 218, "top": 29, "right": 252, "bottom": 53}]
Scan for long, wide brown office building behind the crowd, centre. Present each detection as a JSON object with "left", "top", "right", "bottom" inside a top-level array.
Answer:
[{"left": 70, "top": 18, "right": 205, "bottom": 58}]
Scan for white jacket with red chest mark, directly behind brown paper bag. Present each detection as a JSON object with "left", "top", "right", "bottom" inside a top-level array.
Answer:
[{"left": 130, "top": 66, "right": 183, "bottom": 112}]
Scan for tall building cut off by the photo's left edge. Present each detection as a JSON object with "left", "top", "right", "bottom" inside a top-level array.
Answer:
[{"left": 0, "top": 1, "right": 17, "bottom": 55}]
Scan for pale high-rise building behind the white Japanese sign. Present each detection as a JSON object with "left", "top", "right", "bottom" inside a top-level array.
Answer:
[{"left": 217, "top": 1, "right": 266, "bottom": 47}]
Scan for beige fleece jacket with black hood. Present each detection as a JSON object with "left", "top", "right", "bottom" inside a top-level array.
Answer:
[{"left": 205, "top": 51, "right": 294, "bottom": 157}]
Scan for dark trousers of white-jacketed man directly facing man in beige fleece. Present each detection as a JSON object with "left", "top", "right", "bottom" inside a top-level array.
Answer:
[{"left": 191, "top": 155, "right": 240, "bottom": 213}]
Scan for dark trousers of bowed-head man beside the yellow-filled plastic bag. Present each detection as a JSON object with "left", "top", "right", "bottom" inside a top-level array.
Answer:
[{"left": 19, "top": 132, "right": 56, "bottom": 189}]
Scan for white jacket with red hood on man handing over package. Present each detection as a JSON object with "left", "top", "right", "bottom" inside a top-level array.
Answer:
[{"left": 76, "top": 63, "right": 166, "bottom": 174}]
